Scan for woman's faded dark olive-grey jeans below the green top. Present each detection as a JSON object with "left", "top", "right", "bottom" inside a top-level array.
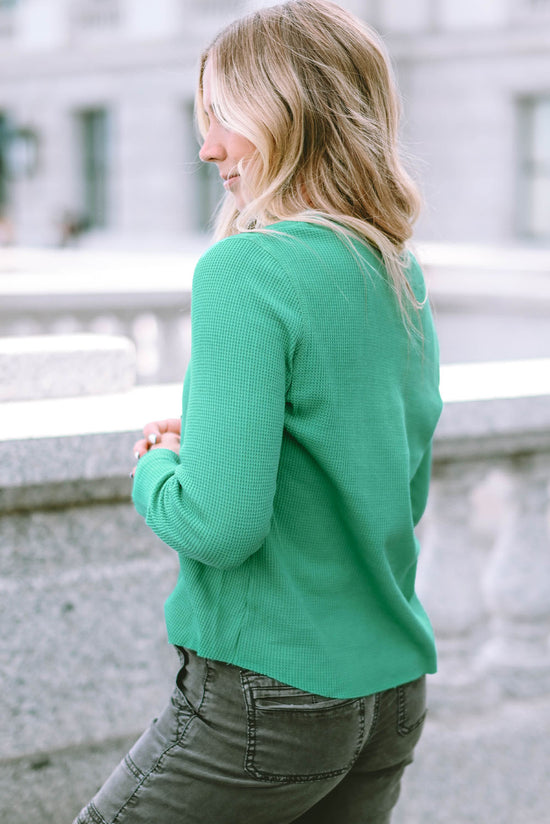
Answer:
[{"left": 74, "top": 649, "right": 425, "bottom": 824}]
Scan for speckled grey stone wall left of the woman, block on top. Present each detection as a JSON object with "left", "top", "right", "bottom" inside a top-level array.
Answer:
[{"left": 0, "top": 336, "right": 181, "bottom": 824}]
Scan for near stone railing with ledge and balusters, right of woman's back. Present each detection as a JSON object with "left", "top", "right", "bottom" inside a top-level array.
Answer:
[{"left": 419, "top": 360, "right": 550, "bottom": 711}]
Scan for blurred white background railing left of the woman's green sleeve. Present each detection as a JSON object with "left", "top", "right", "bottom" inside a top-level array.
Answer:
[{"left": 0, "top": 249, "right": 198, "bottom": 383}]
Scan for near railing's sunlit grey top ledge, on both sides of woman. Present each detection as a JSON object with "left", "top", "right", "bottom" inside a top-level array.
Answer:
[{"left": 0, "top": 359, "right": 550, "bottom": 511}]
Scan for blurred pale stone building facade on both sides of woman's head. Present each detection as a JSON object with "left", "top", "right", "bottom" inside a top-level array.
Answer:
[{"left": 0, "top": 0, "right": 550, "bottom": 247}]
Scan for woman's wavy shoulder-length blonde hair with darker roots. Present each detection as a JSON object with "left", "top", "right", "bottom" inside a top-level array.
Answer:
[{"left": 196, "top": 0, "right": 421, "bottom": 320}]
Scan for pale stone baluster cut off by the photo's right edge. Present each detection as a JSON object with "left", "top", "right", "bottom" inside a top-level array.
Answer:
[{"left": 482, "top": 453, "right": 550, "bottom": 698}]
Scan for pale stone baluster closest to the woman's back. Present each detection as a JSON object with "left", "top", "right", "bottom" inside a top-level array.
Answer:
[{"left": 418, "top": 461, "right": 494, "bottom": 709}]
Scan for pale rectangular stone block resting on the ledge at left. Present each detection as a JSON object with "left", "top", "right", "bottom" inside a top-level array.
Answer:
[{"left": 0, "top": 334, "right": 136, "bottom": 401}]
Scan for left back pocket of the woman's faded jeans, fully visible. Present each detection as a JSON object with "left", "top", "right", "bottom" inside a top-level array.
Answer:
[{"left": 241, "top": 670, "right": 374, "bottom": 783}]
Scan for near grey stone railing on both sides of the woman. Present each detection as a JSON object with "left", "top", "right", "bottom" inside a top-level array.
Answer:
[{"left": 0, "top": 339, "right": 550, "bottom": 824}]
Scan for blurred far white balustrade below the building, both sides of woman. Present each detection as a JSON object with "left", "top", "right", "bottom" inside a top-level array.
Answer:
[{"left": 0, "top": 240, "right": 550, "bottom": 384}]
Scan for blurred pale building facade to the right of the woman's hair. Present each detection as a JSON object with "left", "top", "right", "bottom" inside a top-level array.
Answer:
[{"left": 386, "top": 0, "right": 550, "bottom": 246}]
